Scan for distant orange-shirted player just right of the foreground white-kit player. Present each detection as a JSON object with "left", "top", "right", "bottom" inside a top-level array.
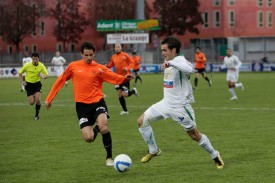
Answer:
[{"left": 194, "top": 47, "right": 212, "bottom": 89}]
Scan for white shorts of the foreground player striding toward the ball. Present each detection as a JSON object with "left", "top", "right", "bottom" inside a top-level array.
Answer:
[{"left": 143, "top": 100, "right": 196, "bottom": 131}]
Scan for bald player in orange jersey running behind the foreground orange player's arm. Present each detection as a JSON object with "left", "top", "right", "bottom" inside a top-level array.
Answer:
[{"left": 106, "top": 43, "right": 138, "bottom": 115}]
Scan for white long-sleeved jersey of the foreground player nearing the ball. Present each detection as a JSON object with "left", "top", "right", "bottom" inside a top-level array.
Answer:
[{"left": 163, "top": 56, "right": 195, "bottom": 107}]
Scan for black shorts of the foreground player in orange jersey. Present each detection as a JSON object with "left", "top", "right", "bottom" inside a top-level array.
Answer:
[{"left": 75, "top": 98, "right": 109, "bottom": 129}]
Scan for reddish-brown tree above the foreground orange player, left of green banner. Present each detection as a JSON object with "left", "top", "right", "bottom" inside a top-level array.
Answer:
[{"left": 49, "top": 0, "right": 88, "bottom": 50}]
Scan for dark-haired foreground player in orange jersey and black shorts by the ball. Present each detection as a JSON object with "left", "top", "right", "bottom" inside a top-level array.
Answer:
[{"left": 45, "top": 42, "right": 134, "bottom": 166}]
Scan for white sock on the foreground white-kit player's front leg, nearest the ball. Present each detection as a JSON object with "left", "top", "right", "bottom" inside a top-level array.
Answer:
[{"left": 139, "top": 125, "right": 158, "bottom": 154}]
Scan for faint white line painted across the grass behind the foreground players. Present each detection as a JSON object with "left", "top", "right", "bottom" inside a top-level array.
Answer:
[{"left": 0, "top": 102, "right": 275, "bottom": 111}]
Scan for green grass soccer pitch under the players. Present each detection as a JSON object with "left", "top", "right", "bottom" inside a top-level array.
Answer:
[{"left": 0, "top": 73, "right": 275, "bottom": 183}]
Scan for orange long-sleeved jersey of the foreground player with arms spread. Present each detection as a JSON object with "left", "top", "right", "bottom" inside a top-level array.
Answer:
[{"left": 46, "top": 60, "right": 125, "bottom": 104}]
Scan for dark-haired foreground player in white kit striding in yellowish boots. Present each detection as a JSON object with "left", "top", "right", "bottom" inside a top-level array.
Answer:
[{"left": 138, "top": 36, "right": 224, "bottom": 169}]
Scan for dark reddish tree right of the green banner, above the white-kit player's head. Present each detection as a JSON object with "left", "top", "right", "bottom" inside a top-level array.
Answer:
[{"left": 153, "top": 0, "right": 203, "bottom": 35}]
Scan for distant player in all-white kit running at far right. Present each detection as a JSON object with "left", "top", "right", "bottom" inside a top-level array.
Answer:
[{"left": 221, "top": 48, "right": 244, "bottom": 100}]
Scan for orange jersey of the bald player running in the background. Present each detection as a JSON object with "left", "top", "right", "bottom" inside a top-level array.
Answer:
[{"left": 107, "top": 52, "right": 134, "bottom": 76}]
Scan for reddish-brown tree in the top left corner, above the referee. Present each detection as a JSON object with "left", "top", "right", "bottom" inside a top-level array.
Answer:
[{"left": 0, "top": 0, "right": 41, "bottom": 52}]
